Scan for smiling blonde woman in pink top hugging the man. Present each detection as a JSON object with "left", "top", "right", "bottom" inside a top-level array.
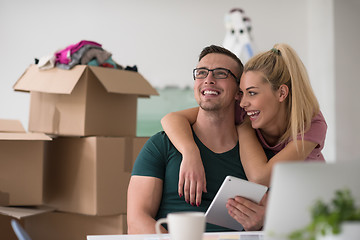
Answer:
[{"left": 161, "top": 44, "right": 327, "bottom": 210}]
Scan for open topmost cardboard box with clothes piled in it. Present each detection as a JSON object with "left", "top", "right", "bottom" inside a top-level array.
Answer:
[{"left": 14, "top": 65, "right": 159, "bottom": 136}]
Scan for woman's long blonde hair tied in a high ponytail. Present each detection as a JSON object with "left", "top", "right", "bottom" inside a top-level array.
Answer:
[{"left": 244, "top": 43, "right": 320, "bottom": 150}]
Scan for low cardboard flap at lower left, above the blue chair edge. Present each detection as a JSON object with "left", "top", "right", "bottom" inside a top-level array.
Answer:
[{"left": 0, "top": 206, "right": 55, "bottom": 219}]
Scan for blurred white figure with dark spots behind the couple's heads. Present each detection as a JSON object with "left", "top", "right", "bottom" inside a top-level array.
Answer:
[{"left": 223, "top": 8, "right": 254, "bottom": 64}]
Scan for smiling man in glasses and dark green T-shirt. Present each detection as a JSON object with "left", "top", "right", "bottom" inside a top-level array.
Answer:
[{"left": 127, "top": 45, "right": 265, "bottom": 234}]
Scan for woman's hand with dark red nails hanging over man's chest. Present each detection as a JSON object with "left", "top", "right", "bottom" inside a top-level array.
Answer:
[{"left": 178, "top": 152, "right": 207, "bottom": 206}]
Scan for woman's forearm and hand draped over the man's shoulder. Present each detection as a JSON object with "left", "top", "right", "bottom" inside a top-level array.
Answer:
[{"left": 161, "top": 108, "right": 206, "bottom": 206}]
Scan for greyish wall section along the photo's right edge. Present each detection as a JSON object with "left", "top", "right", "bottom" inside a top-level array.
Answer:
[{"left": 334, "top": 0, "right": 360, "bottom": 161}]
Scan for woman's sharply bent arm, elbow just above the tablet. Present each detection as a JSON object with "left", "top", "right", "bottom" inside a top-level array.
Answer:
[{"left": 237, "top": 120, "right": 317, "bottom": 186}]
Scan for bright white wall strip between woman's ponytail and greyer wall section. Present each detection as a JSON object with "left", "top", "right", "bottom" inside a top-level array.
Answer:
[{"left": 307, "top": 0, "right": 336, "bottom": 162}]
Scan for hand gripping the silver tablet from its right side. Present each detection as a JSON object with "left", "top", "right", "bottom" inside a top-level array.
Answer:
[{"left": 226, "top": 193, "right": 268, "bottom": 231}]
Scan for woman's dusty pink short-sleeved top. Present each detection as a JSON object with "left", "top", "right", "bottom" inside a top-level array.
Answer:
[{"left": 256, "top": 112, "right": 327, "bottom": 162}]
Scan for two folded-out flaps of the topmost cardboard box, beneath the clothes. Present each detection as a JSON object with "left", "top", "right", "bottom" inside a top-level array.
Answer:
[{"left": 13, "top": 65, "right": 159, "bottom": 96}]
